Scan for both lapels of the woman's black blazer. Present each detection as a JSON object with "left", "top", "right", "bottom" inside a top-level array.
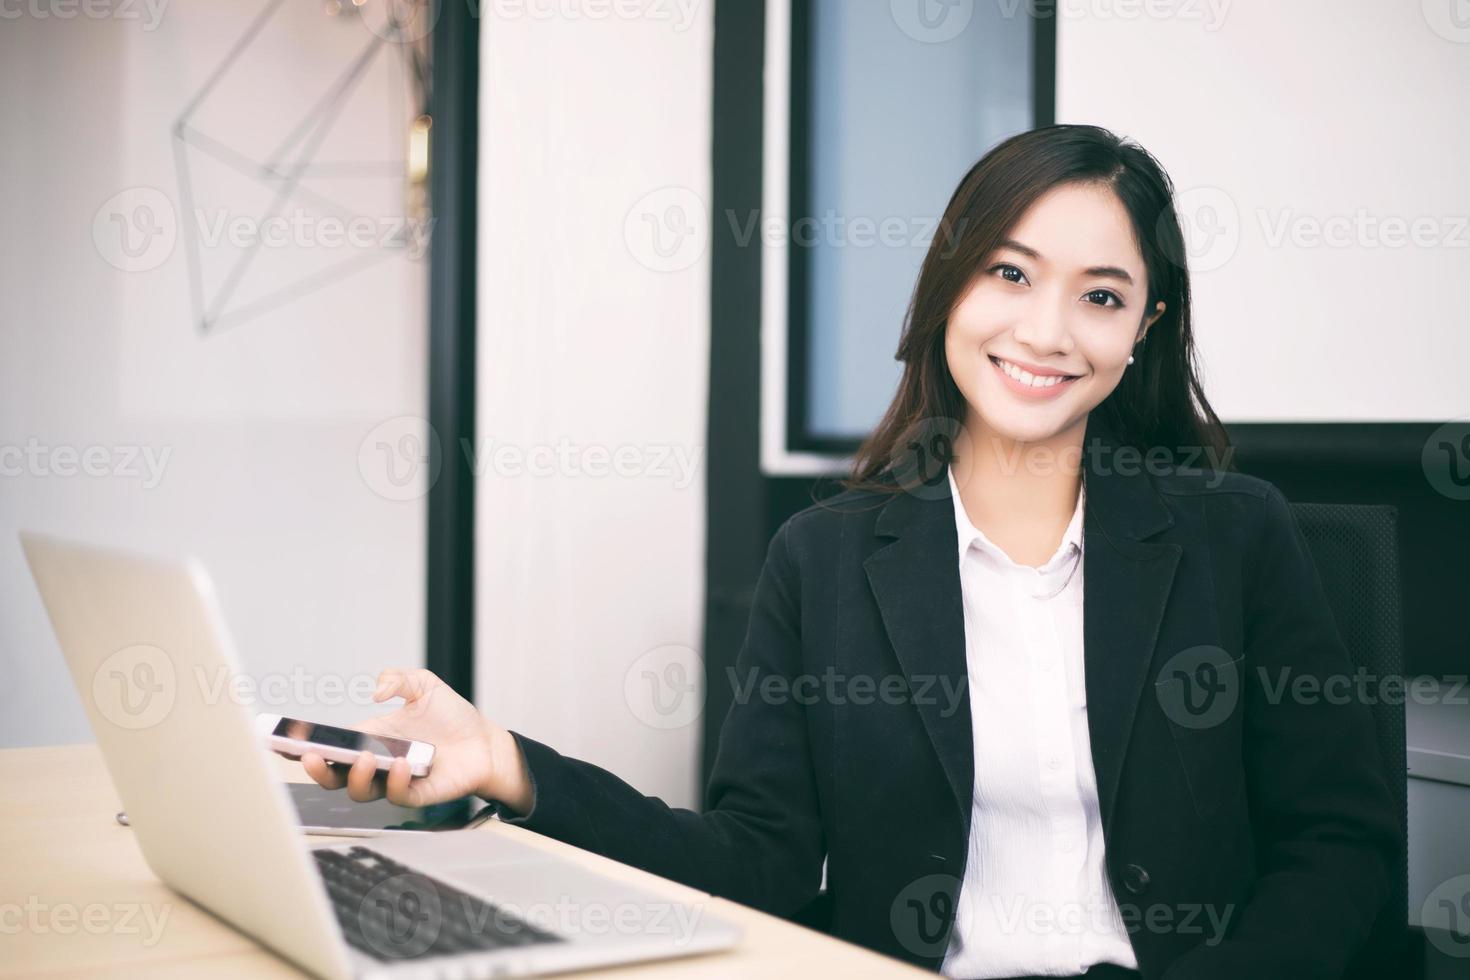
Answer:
[{"left": 863, "top": 411, "right": 1180, "bottom": 829}]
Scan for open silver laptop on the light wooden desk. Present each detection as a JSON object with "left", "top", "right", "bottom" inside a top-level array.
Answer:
[{"left": 21, "top": 533, "right": 739, "bottom": 979}]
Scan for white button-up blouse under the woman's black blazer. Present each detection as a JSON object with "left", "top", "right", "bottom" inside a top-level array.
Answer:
[{"left": 942, "top": 472, "right": 1138, "bottom": 977}]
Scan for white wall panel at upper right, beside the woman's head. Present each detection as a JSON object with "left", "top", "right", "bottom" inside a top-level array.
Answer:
[{"left": 1057, "top": 0, "right": 1470, "bottom": 422}]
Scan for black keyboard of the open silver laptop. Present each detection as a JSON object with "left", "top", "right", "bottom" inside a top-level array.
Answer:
[{"left": 312, "top": 848, "right": 564, "bottom": 961}]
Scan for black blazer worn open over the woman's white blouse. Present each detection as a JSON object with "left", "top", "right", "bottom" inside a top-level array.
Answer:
[{"left": 496, "top": 413, "right": 1402, "bottom": 980}]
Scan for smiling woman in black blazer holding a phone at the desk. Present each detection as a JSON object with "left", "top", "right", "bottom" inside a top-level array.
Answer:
[{"left": 303, "top": 126, "right": 1401, "bottom": 979}]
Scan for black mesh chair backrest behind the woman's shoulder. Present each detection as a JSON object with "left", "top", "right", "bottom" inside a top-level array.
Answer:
[{"left": 1291, "top": 504, "right": 1410, "bottom": 977}]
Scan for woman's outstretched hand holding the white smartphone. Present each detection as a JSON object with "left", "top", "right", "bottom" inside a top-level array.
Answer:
[{"left": 301, "top": 669, "right": 532, "bottom": 814}]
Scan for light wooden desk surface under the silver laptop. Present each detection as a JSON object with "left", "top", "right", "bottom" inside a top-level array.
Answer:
[{"left": 0, "top": 745, "right": 935, "bottom": 980}]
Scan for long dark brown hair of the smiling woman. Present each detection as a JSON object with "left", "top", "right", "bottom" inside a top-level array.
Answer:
[{"left": 845, "top": 125, "right": 1232, "bottom": 491}]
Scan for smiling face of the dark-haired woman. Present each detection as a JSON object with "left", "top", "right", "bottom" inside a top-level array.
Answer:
[{"left": 944, "top": 184, "right": 1164, "bottom": 442}]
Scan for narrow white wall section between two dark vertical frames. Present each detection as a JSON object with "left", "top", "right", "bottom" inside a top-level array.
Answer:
[{"left": 475, "top": 3, "right": 719, "bottom": 805}]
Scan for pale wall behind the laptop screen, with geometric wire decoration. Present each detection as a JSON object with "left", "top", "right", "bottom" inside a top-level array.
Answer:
[{"left": 0, "top": 0, "right": 425, "bottom": 746}]
